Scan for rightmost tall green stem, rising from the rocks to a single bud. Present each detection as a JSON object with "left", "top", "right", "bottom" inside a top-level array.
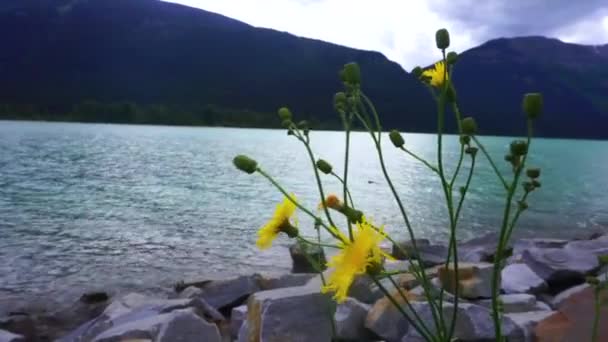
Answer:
[{"left": 492, "top": 119, "right": 532, "bottom": 341}]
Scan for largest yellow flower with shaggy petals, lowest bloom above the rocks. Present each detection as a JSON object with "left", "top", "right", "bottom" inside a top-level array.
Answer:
[{"left": 321, "top": 219, "right": 385, "bottom": 303}]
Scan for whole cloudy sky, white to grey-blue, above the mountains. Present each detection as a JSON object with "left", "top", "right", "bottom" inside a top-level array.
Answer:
[{"left": 164, "top": 0, "right": 608, "bottom": 70}]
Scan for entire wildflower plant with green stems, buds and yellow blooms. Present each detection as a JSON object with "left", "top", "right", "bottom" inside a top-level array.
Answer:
[{"left": 234, "top": 29, "right": 543, "bottom": 342}]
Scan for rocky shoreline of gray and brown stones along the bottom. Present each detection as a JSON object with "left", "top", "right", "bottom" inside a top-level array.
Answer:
[{"left": 0, "top": 232, "right": 608, "bottom": 342}]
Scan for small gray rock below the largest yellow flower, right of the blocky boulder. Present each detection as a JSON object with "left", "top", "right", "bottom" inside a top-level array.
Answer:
[{"left": 334, "top": 298, "right": 374, "bottom": 341}]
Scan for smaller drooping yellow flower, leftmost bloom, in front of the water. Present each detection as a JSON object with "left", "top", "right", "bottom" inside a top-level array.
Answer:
[{"left": 256, "top": 194, "right": 298, "bottom": 249}]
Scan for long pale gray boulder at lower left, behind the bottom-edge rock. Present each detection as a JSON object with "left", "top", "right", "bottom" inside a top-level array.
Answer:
[{"left": 58, "top": 293, "right": 224, "bottom": 342}]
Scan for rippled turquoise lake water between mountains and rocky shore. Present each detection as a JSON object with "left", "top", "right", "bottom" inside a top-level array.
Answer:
[{"left": 0, "top": 121, "right": 608, "bottom": 297}]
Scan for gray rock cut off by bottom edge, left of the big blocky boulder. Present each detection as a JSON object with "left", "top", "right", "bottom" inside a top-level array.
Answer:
[{"left": 92, "top": 309, "right": 221, "bottom": 342}]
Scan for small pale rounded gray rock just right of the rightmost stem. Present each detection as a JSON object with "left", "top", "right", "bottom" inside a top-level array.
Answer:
[{"left": 501, "top": 264, "right": 547, "bottom": 294}]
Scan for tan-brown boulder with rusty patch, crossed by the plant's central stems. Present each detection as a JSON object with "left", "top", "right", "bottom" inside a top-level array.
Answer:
[{"left": 439, "top": 263, "right": 494, "bottom": 299}]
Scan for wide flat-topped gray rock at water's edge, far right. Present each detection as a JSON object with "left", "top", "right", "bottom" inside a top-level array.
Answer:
[{"left": 522, "top": 248, "right": 599, "bottom": 287}]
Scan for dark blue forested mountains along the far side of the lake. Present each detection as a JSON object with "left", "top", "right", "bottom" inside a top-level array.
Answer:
[{"left": 0, "top": 0, "right": 608, "bottom": 138}]
